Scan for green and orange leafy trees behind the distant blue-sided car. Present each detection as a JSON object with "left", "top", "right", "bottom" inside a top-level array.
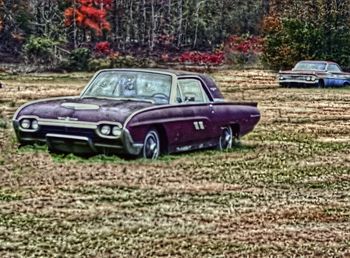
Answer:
[{"left": 263, "top": 0, "right": 350, "bottom": 69}]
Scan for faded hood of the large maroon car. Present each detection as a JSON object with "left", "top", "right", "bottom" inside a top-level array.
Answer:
[{"left": 15, "top": 97, "right": 154, "bottom": 123}]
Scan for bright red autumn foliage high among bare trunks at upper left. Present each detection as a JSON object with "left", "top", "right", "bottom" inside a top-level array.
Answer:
[{"left": 64, "top": 0, "right": 112, "bottom": 36}]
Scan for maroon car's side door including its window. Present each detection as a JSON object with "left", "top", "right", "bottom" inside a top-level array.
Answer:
[{"left": 176, "top": 78, "right": 213, "bottom": 149}]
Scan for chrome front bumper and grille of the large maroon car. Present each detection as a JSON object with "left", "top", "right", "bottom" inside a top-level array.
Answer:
[{"left": 13, "top": 120, "right": 143, "bottom": 155}]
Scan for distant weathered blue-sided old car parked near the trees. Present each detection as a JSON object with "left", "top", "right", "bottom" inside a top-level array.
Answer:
[{"left": 278, "top": 61, "right": 350, "bottom": 88}]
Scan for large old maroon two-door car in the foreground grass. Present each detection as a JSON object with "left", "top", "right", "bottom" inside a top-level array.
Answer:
[{"left": 13, "top": 69, "right": 260, "bottom": 159}]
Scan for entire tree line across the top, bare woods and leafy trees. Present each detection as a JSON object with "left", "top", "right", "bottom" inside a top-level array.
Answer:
[{"left": 0, "top": 0, "right": 350, "bottom": 69}]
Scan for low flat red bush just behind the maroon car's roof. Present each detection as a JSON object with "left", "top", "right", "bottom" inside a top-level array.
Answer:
[{"left": 179, "top": 51, "right": 225, "bottom": 65}]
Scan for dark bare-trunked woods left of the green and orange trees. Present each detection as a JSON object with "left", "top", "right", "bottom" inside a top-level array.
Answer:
[{"left": 0, "top": 0, "right": 262, "bottom": 55}]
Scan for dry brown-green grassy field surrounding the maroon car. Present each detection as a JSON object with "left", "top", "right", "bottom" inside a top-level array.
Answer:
[{"left": 0, "top": 71, "right": 350, "bottom": 257}]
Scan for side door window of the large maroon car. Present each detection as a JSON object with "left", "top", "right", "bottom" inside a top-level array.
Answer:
[{"left": 176, "top": 79, "right": 209, "bottom": 103}]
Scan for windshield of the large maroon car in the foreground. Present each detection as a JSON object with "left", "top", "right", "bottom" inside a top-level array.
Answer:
[{"left": 82, "top": 71, "right": 172, "bottom": 104}]
